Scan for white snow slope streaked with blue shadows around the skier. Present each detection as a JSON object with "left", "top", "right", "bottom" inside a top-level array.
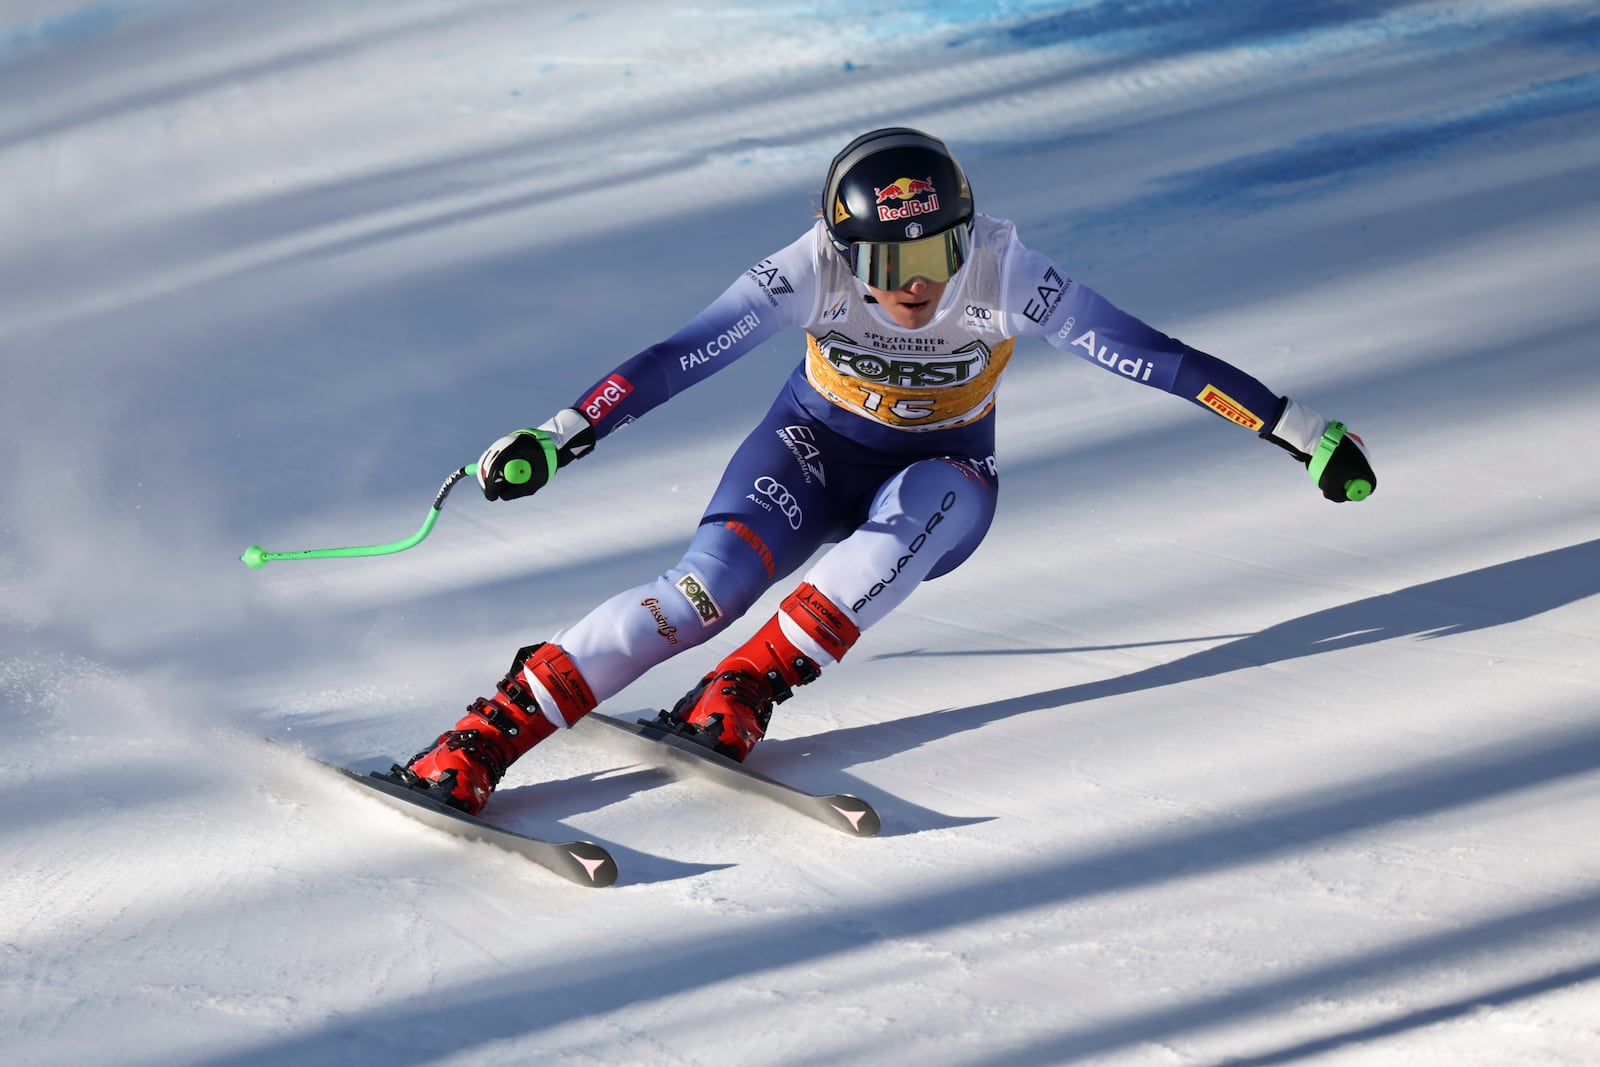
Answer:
[{"left": 0, "top": 0, "right": 1600, "bottom": 1067}]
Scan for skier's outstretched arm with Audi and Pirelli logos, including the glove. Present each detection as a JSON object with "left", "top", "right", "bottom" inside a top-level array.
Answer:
[{"left": 1005, "top": 245, "right": 1378, "bottom": 502}]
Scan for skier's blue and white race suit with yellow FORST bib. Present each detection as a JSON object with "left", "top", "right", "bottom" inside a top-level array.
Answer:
[{"left": 536, "top": 214, "right": 1278, "bottom": 725}]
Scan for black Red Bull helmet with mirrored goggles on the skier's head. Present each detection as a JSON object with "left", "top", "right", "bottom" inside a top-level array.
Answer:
[{"left": 822, "top": 126, "right": 973, "bottom": 290}]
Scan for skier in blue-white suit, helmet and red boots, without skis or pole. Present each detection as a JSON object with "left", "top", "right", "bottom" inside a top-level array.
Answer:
[{"left": 392, "top": 126, "right": 1376, "bottom": 814}]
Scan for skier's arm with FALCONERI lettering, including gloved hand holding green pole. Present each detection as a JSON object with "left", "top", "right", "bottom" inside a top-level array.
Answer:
[{"left": 478, "top": 230, "right": 818, "bottom": 501}]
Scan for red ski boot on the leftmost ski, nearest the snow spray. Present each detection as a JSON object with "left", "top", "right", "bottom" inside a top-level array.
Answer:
[{"left": 389, "top": 645, "right": 594, "bottom": 814}]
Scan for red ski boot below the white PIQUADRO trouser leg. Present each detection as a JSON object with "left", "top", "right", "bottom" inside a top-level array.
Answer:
[{"left": 661, "top": 584, "right": 861, "bottom": 763}]
